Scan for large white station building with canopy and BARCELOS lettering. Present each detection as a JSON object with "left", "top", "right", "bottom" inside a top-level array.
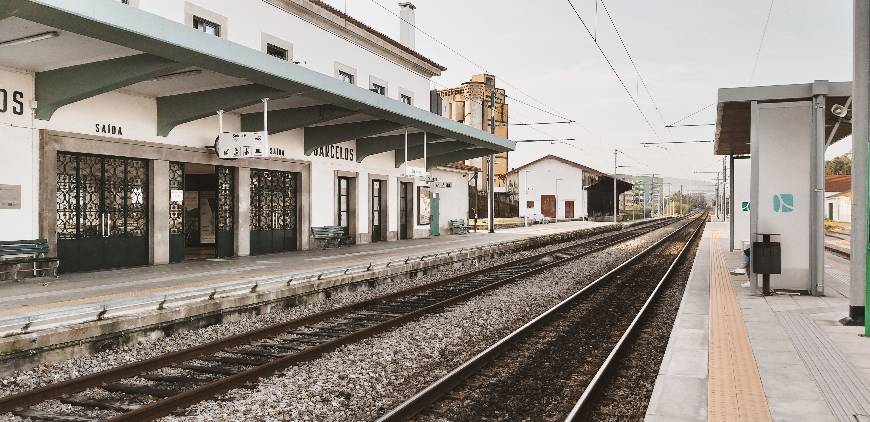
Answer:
[{"left": 0, "top": 0, "right": 514, "bottom": 271}]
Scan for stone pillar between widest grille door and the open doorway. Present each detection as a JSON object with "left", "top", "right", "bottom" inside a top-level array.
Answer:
[{"left": 148, "top": 160, "right": 169, "bottom": 265}]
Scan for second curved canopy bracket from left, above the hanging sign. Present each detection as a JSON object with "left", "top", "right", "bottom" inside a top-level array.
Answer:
[{"left": 157, "top": 84, "right": 292, "bottom": 136}]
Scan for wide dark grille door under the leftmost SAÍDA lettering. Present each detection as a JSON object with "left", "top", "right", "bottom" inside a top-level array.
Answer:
[{"left": 57, "top": 152, "right": 150, "bottom": 272}]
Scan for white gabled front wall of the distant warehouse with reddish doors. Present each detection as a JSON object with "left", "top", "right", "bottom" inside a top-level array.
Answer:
[{"left": 509, "top": 159, "right": 587, "bottom": 218}]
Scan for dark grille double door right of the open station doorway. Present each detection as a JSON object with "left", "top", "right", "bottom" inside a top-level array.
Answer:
[{"left": 251, "top": 169, "right": 299, "bottom": 255}]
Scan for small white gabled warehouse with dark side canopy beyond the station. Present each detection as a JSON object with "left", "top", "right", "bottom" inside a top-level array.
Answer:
[{"left": 507, "top": 155, "right": 631, "bottom": 219}]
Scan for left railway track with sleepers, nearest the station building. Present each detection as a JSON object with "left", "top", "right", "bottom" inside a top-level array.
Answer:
[{"left": 0, "top": 216, "right": 673, "bottom": 422}]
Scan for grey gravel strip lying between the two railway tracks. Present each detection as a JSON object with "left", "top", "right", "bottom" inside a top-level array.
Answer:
[{"left": 157, "top": 223, "right": 684, "bottom": 421}]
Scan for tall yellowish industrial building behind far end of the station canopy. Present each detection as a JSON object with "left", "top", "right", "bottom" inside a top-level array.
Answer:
[{"left": 436, "top": 74, "right": 508, "bottom": 192}]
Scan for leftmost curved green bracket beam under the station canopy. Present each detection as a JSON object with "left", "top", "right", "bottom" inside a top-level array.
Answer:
[{"left": 36, "top": 54, "right": 190, "bottom": 120}]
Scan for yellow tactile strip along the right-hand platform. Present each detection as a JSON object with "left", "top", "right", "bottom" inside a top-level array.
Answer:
[{"left": 707, "top": 226, "right": 771, "bottom": 422}]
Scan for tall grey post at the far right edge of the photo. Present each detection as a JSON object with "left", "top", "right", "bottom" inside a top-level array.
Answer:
[{"left": 846, "top": 0, "right": 870, "bottom": 324}]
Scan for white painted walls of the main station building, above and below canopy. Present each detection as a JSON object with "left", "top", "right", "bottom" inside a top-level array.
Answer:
[{"left": 0, "top": 0, "right": 476, "bottom": 244}]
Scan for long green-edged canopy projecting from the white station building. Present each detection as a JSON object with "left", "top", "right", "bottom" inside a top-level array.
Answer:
[{"left": 0, "top": 0, "right": 515, "bottom": 167}]
